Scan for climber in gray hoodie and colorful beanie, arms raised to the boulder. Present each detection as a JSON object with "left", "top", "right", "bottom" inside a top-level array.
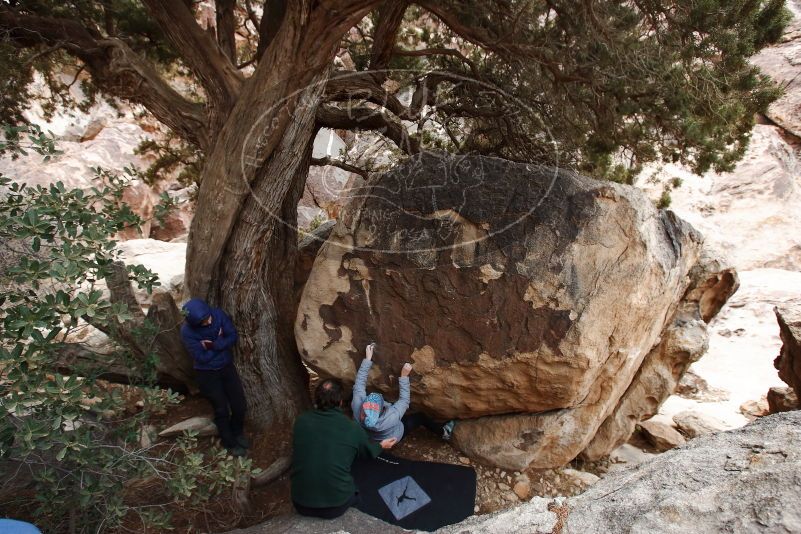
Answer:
[{"left": 350, "top": 343, "right": 454, "bottom": 441}]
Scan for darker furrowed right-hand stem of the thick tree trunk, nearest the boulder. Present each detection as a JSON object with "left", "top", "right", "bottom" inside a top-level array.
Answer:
[{"left": 215, "top": 126, "right": 314, "bottom": 427}]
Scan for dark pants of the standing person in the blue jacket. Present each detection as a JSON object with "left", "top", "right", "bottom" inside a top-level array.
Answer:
[{"left": 195, "top": 363, "right": 247, "bottom": 449}]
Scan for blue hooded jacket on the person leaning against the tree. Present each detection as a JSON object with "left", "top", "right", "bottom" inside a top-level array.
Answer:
[{"left": 181, "top": 299, "right": 238, "bottom": 371}]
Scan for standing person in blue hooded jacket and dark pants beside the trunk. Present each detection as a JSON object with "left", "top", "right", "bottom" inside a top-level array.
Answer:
[{"left": 181, "top": 298, "right": 249, "bottom": 456}]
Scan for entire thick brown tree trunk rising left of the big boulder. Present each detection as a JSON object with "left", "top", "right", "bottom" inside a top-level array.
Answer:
[{"left": 186, "top": 0, "right": 377, "bottom": 436}]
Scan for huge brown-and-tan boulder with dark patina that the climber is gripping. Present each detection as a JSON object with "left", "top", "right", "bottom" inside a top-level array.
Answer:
[{"left": 295, "top": 154, "right": 704, "bottom": 469}]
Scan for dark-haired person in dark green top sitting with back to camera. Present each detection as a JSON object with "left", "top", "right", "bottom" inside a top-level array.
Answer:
[{"left": 291, "top": 379, "right": 397, "bottom": 519}]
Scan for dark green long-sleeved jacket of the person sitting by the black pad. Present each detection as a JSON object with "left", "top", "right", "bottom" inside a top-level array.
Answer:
[{"left": 291, "top": 408, "right": 381, "bottom": 508}]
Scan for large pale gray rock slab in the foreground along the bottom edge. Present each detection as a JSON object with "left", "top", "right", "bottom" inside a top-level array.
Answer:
[{"left": 234, "top": 411, "right": 801, "bottom": 534}]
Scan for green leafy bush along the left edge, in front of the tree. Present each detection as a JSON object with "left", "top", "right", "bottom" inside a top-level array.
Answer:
[{"left": 0, "top": 127, "right": 251, "bottom": 532}]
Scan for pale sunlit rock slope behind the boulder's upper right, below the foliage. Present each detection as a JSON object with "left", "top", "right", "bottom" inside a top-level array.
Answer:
[{"left": 637, "top": 125, "right": 801, "bottom": 273}]
